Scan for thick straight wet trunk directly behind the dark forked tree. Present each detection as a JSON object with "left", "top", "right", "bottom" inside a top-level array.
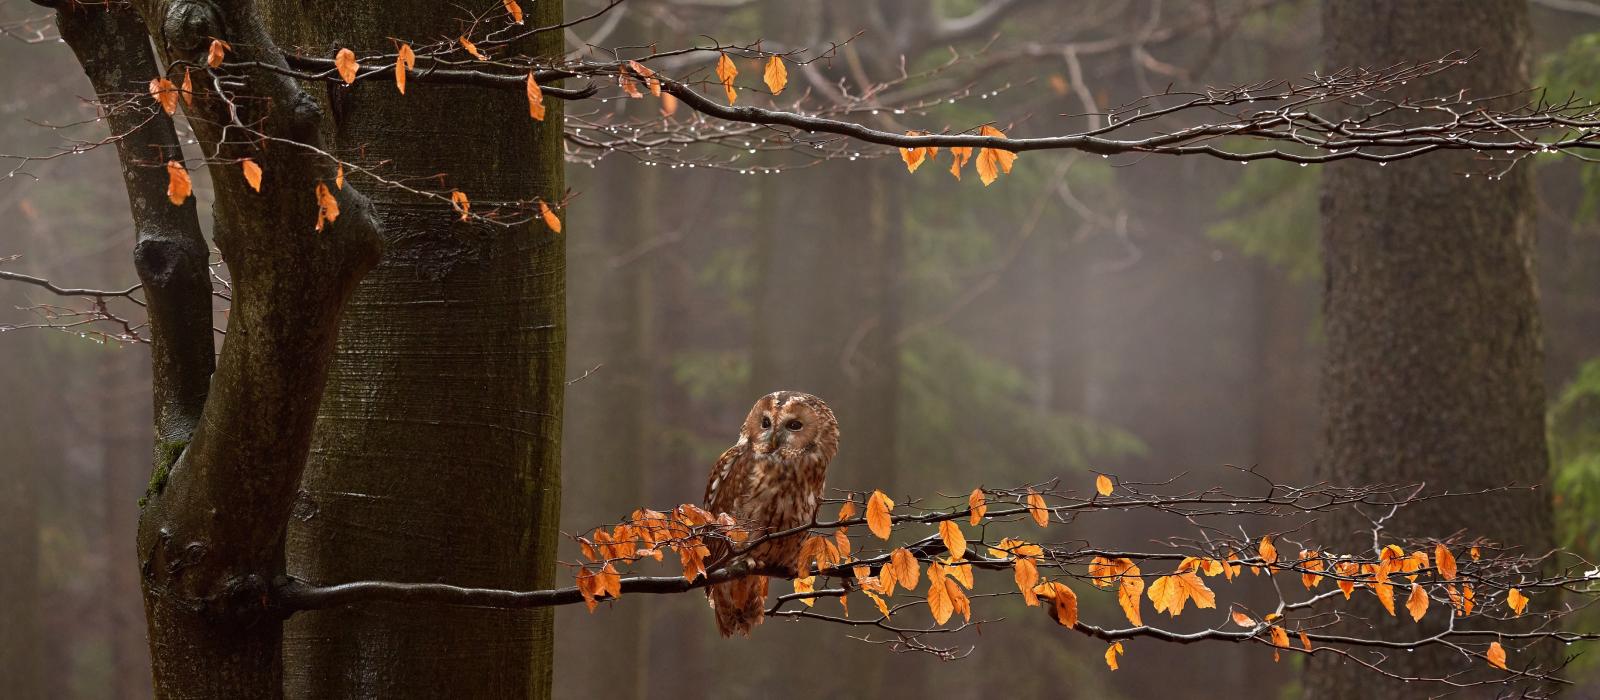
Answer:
[{"left": 275, "top": 0, "right": 565, "bottom": 698}]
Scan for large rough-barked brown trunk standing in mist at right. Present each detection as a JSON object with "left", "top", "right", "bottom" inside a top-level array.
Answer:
[{"left": 1306, "top": 0, "right": 1550, "bottom": 698}]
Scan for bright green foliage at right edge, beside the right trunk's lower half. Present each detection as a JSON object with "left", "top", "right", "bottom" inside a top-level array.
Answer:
[{"left": 1549, "top": 358, "right": 1600, "bottom": 559}]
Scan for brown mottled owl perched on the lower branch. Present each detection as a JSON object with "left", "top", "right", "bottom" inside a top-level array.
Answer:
[{"left": 706, "top": 392, "right": 838, "bottom": 636}]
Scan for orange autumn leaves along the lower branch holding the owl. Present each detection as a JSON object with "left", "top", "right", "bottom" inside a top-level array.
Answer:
[{"left": 578, "top": 475, "right": 1528, "bottom": 670}]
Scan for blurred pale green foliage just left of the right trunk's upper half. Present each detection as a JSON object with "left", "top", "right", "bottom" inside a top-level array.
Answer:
[{"left": 1206, "top": 161, "right": 1322, "bottom": 281}]
